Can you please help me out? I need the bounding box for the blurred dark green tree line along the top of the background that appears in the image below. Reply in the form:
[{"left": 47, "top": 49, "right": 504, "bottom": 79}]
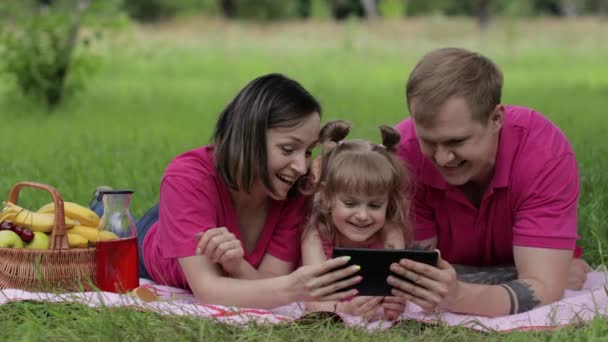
[{"left": 111, "top": 0, "right": 608, "bottom": 22}]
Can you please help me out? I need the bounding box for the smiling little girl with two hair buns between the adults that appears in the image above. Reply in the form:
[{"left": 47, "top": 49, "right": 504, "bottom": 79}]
[{"left": 302, "top": 121, "right": 412, "bottom": 320}]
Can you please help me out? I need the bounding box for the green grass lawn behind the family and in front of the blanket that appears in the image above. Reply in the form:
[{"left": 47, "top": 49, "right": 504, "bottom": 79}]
[{"left": 0, "top": 18, "right": 608, "bottom": 341}]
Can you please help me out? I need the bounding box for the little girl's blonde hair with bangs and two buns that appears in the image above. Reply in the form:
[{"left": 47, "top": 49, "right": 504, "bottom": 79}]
[{"left": 304, "top": 120, "right": 412, "bottom": 246}]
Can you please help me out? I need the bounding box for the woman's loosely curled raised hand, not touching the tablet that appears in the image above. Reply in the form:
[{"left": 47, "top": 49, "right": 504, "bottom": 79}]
[{"left": 195, "top": 227, "right": 245, "bottom": 274}]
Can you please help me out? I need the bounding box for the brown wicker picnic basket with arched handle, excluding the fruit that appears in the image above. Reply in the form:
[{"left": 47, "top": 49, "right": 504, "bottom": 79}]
[{"left": 0, "top": 182, "right": 96, "bottom": 292}]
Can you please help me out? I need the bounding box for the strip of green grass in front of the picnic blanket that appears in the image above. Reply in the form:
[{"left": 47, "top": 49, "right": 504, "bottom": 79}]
[{"left": 0, "top": 302, "right": 608, "bottom": 342}]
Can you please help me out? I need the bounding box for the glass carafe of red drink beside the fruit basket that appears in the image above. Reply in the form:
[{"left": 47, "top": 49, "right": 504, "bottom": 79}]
[{"left": 96, "top": 190, "right": 139, "bottom": 293}]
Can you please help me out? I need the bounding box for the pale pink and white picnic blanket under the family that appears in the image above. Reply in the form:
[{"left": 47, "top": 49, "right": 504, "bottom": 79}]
[{"left": 0, "top": 270, "right": 608, "bottom": 331}]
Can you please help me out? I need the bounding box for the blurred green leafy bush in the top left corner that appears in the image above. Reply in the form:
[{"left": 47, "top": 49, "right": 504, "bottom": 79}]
[{"left": 0, "top": 0, "right": 123, "bottom": 107}]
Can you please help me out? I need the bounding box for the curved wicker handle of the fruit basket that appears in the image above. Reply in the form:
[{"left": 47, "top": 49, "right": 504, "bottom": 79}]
[{"left": 8, "top": 181, "right": 70, "bottom": 250}]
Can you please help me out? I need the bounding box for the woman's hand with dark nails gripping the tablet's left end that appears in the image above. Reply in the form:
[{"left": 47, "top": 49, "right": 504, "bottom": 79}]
[{"left": 287, "top": 257, "right": 363, "bottom": 302}]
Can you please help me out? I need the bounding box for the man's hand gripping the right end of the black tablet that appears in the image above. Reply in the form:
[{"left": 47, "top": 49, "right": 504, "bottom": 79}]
[{"left": 387, "top": 252, "right": 460, "bottom": 311}]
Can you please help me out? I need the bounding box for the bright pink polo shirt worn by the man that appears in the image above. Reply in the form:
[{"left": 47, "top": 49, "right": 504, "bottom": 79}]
[{"left": 396, "top": 106, "right": 580, "bottom": 266}]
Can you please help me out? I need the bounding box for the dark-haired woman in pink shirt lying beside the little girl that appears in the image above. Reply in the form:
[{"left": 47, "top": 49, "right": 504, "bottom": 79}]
[{"left": 92, "top": 74, "right": 359, "bottom": 308}]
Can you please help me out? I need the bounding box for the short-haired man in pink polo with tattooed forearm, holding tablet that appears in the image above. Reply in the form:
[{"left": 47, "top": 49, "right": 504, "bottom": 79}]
[{"left": 388, "top": 48, "right": 589, "bottom": 316}]
